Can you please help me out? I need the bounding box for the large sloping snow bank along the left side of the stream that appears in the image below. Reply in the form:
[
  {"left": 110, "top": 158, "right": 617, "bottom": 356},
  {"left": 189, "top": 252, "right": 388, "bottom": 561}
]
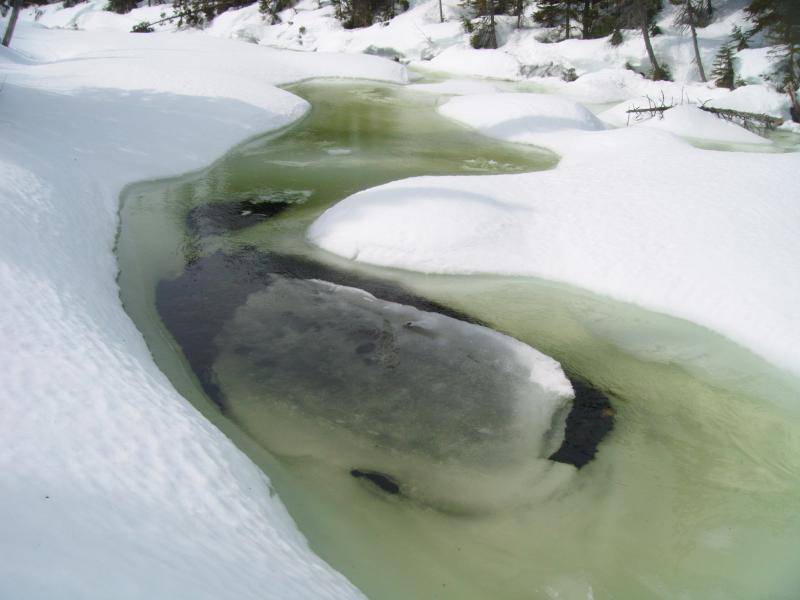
[{"left": 0, "top": 23, "right": 405, "bottom": 600}]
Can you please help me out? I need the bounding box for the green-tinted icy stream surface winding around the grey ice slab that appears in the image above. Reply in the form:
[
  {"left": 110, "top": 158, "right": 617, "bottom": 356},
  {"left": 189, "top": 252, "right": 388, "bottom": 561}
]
[{"left": 118, "top": 83, "right": 800, "bottom": 600}]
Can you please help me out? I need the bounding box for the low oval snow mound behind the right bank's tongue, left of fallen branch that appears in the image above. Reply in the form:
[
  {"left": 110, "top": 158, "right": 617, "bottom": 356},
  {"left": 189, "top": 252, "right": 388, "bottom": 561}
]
[{"left": 439, "top": 93, "right": 604, "bottom": 141}]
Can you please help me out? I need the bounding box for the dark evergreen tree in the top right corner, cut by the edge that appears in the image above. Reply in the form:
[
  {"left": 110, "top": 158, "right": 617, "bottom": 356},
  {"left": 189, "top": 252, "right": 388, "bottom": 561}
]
[{"left": 745, "top": 0, "right": 800, "bottom": 122}]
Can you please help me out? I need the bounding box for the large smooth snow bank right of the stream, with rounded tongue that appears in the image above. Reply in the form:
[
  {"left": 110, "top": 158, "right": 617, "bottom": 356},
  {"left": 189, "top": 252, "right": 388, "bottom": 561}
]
[{"left": 308, "top": 94, "right": 800, "bottom": 380}]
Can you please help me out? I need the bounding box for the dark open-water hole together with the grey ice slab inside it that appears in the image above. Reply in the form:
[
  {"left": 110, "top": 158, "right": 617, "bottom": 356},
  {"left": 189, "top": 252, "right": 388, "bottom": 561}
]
[{"left": 156, "top": 247, "right": 613, "bottom": 511}]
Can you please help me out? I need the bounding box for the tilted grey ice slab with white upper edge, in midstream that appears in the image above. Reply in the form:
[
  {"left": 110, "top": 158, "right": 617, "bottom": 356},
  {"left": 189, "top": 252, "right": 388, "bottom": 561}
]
[{"left": 214, "top": 274, "right": 573, "bottom": 465}]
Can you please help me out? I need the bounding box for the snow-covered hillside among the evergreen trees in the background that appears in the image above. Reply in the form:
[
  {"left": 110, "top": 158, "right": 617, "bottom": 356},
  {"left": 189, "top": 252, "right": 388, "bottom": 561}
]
[{"left": 14, "top": 0, "right": 800, "bottom": 122}]
